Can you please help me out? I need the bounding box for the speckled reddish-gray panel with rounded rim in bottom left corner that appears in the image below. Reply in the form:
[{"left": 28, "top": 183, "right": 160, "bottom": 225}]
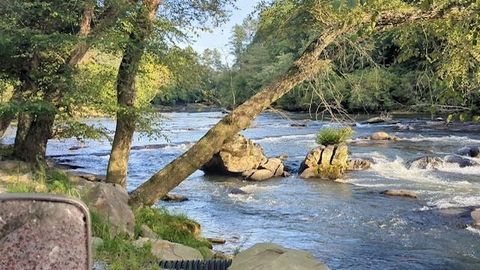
[{"left": 0, "top": 193, "right": 92, "bottom": 270}]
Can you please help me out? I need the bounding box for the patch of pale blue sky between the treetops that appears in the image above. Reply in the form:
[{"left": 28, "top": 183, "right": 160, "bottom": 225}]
[{"left": 188, "top": 0, "right": 260, "bottom": 62}]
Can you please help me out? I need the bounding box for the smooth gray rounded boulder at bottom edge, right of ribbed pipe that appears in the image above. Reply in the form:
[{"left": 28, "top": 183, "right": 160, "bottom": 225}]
[{"left": 228, "top": 243, "right": 329, "bottom": 270}]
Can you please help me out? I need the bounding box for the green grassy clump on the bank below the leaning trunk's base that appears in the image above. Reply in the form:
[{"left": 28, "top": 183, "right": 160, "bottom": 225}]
[{"left": 135, "top": 207, "right": 211, "bottom": 257}]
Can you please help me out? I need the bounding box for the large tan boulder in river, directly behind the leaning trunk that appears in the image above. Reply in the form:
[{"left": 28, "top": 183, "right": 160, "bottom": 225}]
[{"left": 202, "top": 135, "right": 284, "bottom": 181}]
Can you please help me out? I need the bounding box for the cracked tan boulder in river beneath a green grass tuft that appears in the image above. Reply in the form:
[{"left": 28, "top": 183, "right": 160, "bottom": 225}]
[{"left": 299, "top": 144, "right": 349, "bottom": 179}]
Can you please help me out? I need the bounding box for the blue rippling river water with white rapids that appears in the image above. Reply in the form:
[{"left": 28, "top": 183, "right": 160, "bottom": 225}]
[{"left": 31, "top": 112, "right": 480, "bottom": 269}]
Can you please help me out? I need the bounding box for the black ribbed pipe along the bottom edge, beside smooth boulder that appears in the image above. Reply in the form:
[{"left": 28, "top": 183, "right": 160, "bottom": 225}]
[{"left": 159, "top": 260, "right": 232, "bottom": 270}]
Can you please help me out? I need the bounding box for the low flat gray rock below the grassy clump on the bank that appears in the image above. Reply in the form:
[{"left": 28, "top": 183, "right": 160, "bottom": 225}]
[{"left": 133, "top": 238, "right": 203, "bottom": 261}]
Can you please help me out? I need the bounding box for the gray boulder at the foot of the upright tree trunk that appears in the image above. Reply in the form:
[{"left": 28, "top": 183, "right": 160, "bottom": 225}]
[{"left": 84, "top": 183, "right": 135, "bottom": 235}]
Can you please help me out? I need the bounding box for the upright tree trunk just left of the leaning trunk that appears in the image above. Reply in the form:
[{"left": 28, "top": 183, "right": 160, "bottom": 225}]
[{"left": 106, "top": 0, "right": 161, "bottom": 186}]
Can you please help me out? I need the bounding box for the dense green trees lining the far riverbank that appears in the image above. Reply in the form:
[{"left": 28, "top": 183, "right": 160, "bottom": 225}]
[{"left": 154, "top": 0, "right": 480, "bottom": 114}]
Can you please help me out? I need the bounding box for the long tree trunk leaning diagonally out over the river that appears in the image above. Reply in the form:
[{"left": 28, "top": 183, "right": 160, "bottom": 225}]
[{"left": 129, "top": 7, "right": 441, "bottom": 207}]
